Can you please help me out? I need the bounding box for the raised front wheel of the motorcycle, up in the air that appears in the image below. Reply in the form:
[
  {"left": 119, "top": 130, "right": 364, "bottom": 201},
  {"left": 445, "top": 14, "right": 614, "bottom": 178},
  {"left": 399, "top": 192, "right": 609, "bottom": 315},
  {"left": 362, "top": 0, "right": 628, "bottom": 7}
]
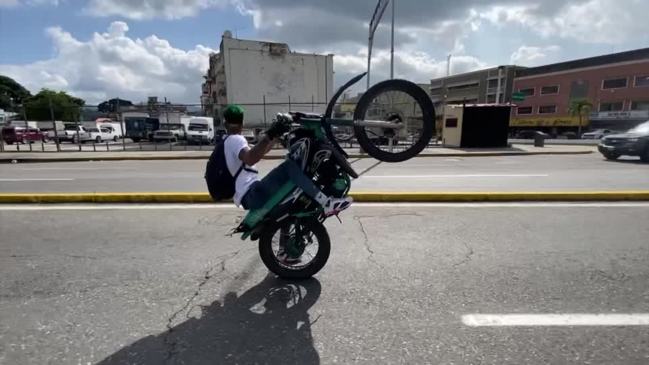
[{"left": 354, "top": 80, "right": 435, "bottom": 162}]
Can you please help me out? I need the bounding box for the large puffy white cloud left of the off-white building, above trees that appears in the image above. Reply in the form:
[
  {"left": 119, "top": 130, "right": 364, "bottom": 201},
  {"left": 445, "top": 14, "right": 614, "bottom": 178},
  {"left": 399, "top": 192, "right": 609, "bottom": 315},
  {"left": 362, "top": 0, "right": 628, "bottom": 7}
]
[{"left": 0, "top": 22, "right": 214, "bottom": 104}]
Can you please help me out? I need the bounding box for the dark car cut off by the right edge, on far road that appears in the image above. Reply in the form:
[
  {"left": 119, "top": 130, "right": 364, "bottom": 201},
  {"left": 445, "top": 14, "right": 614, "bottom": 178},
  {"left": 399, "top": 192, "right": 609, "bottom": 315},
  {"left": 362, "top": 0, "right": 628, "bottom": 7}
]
[{"left": 597, "top": 120, "right": 649, "bottom": 162}]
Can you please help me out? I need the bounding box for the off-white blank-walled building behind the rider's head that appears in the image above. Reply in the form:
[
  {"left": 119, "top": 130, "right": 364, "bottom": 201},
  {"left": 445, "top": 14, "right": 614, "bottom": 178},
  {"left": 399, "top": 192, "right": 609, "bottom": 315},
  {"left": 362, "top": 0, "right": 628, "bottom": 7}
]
[{"left": 201, "top": 31, "right": 333, "bottom": 127}]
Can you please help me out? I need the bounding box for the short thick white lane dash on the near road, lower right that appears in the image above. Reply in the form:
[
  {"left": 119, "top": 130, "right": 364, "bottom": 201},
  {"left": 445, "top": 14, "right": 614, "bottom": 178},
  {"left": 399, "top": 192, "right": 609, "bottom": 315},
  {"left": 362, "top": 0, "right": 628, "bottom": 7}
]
[{"left": 462, "top": 313, "right": 649, "bottom": 327}]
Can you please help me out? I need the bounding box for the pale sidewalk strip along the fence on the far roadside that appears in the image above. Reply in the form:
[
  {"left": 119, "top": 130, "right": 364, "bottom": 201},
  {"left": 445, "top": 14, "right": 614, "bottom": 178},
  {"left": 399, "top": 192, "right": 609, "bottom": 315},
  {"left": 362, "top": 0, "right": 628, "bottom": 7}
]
[{"left": 0, "top": 145, "right": 596, "bottom": 163}]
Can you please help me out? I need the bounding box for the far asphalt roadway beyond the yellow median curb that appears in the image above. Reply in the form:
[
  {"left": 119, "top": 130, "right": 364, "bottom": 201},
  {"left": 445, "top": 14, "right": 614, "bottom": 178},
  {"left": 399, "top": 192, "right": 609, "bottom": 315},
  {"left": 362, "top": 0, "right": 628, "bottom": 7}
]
[{"left": 0, "top": 153, "right": 649, "bottom": 192}]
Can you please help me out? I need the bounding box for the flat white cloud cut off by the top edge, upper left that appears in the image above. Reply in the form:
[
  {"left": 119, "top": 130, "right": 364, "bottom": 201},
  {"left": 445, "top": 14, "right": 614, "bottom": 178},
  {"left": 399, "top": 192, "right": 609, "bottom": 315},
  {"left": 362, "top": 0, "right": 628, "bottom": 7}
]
[{"left": 84, "top": 0, "right": 229, "bottom": 20}]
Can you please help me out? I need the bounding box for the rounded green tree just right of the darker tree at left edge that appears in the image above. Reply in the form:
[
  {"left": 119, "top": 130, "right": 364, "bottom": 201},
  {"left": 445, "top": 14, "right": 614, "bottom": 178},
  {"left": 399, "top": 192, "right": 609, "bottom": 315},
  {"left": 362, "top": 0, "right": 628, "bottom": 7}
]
[{"left": 25, "top": 89, "right": 86, "bottom": 121}]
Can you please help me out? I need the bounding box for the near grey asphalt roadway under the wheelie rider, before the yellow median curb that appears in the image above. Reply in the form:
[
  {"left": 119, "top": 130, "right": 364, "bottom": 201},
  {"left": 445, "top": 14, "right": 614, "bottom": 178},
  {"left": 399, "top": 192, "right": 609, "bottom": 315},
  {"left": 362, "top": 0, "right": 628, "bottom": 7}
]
[{"left": 0, "top": 203, "right": 649, "bottom": 364}]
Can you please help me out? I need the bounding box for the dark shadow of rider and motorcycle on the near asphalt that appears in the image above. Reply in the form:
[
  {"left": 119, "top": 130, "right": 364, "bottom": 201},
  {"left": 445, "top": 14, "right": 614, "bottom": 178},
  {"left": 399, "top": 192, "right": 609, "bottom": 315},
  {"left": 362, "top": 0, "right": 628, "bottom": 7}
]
[{"left": 99, "top": 275, "right": 321, "bottom": 365}]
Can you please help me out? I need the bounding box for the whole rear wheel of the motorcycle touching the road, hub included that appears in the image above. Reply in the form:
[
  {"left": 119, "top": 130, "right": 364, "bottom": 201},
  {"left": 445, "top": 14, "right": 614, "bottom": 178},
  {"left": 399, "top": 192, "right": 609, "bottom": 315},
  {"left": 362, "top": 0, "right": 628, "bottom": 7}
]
[{"left": 259, "top": 218, "right": 331, "bottom": 279}]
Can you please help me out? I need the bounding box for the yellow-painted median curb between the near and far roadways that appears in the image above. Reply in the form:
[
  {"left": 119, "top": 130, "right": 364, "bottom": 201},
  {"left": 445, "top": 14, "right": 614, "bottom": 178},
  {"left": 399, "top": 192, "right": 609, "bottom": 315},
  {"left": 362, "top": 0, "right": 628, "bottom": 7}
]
[{"left": 0, "top": 190, "right": 649, "bottom": 204}]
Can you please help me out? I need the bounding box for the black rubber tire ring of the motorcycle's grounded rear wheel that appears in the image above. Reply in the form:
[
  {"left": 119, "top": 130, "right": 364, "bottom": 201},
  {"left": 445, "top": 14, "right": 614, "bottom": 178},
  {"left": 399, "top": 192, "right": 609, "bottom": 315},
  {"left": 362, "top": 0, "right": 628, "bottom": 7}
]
[{"left": 259, "top": 218, "right": 331, "bottom": 280}]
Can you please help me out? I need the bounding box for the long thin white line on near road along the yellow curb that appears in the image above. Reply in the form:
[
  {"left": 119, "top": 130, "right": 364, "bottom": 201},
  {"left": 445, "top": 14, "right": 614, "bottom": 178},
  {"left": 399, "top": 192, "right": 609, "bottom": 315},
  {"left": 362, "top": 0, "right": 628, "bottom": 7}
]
[{"left": 0, "top": 202, "right": 649, "bottom": 210}]
